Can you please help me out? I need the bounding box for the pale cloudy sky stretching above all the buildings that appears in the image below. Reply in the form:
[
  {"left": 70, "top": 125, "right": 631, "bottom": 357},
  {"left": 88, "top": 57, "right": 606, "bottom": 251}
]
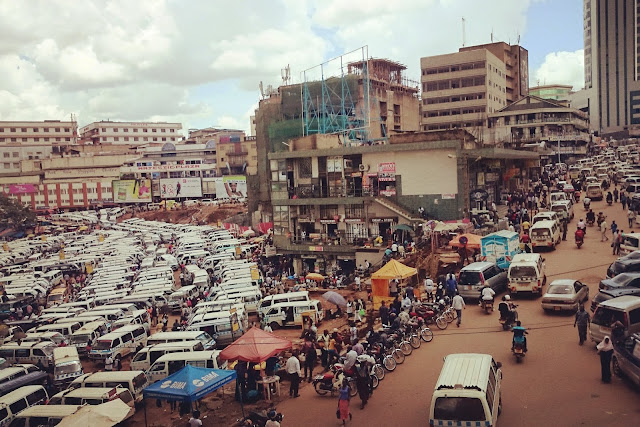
[{"left": 0, "top": 0, "right": 583, "bottom": 133}]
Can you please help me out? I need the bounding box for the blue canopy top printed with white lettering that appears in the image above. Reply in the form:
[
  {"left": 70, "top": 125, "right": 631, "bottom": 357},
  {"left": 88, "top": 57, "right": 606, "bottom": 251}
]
[{"left": 142, "top": 365, "right": 236, "bottom": 402}]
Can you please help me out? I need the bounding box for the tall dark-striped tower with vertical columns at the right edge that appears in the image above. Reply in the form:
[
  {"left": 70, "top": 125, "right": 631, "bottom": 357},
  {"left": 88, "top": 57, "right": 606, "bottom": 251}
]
[{"left": 583, "top": 0, "right": 640, "bottom": 135}]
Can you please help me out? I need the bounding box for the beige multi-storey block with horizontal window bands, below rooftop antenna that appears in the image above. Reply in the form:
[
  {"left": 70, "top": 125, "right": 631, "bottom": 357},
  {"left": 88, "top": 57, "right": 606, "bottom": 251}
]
[{"left": 420, "top": 49, "right": 507, "bottom": 141}]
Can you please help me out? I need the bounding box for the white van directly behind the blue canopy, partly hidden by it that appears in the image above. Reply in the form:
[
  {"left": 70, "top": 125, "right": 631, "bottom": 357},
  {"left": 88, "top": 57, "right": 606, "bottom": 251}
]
[{"left": 147, "top": 350, "right": 227, "bottom": 383}]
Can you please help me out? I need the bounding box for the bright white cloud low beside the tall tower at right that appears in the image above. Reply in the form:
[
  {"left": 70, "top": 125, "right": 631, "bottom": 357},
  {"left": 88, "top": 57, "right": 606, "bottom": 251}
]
[{"left": 530, "top": 49, "right": 584, "bottom": 90}]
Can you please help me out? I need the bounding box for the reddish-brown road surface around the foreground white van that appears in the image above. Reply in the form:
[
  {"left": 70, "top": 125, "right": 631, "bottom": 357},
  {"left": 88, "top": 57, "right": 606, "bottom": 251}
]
[{"left": 278, "top": 202, "right": 640, "bottom": 426}]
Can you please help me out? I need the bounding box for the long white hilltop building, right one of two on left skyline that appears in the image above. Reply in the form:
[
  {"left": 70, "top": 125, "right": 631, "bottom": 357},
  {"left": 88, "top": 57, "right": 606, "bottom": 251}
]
[{"left": 80, "top": 121, "right": 183, "bottom": 146}]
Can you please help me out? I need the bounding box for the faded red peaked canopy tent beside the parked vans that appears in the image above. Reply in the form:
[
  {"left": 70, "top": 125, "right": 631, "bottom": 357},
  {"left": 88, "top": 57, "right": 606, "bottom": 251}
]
[{"left": 220, "top": 326, "right": 292, "bottom": 363}]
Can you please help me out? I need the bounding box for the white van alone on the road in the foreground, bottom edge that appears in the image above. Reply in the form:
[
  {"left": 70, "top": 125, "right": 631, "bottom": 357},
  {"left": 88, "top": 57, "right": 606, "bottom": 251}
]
[{"left": 429, "top": 353, "right": 502, "bottom": 426}]
